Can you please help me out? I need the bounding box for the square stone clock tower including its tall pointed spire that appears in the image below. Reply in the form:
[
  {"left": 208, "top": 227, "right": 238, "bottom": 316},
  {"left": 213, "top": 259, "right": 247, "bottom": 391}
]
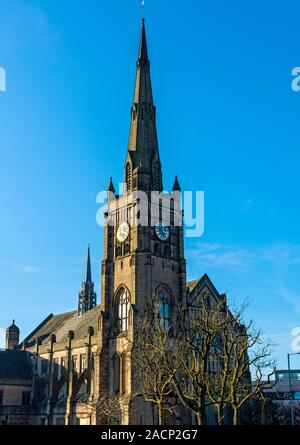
[{"left": 99, "top": 19, "right": 186, "bottom": 424}]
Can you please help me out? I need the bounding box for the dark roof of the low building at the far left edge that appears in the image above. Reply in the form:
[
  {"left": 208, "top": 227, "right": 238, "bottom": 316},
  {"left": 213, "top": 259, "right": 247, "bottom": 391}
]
[{"left": 0, "top": 349, "right": 32, "bottom": 380}]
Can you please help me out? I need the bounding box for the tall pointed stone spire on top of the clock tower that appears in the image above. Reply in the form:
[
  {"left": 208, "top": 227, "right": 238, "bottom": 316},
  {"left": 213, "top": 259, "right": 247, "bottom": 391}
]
[{"left": 124, "top": 18, "right": 163, "bottom": 191}]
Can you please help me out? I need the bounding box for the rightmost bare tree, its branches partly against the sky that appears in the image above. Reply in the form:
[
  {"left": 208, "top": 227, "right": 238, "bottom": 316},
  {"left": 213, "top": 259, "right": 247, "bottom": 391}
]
[{"left": 207, "top": 305, "right": 275, "bottom": 425}]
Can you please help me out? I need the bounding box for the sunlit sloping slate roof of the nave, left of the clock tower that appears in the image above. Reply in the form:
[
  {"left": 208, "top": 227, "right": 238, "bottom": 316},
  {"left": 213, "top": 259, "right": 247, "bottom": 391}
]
[{"left": 23, "top": 305, "right": 100, "bottom": 348}]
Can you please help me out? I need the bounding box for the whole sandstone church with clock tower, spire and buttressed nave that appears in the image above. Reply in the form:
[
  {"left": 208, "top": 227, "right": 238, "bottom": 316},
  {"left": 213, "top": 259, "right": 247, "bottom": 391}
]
[{"left": 0, "top": 20, "right": 226, "bottom": 425}]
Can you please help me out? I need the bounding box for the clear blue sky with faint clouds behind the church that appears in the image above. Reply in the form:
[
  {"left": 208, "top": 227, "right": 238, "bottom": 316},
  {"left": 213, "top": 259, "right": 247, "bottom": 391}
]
[{"left": 0, "top": 0, "right": 300, "bottom": 367}]
